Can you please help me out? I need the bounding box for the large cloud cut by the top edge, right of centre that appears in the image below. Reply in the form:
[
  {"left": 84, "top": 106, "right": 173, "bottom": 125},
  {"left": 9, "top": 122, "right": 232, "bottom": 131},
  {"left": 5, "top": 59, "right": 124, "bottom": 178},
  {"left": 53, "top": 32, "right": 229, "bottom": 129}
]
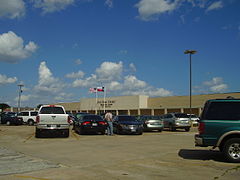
[{"left": 135, "top": 0, "right": 180, "bottom": 21}]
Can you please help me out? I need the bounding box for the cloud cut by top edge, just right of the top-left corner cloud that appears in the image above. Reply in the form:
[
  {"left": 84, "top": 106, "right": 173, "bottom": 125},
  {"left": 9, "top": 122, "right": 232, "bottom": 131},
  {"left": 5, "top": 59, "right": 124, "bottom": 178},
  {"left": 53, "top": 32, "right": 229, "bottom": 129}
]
[{"left": 32, "top": 0, "right": 75, "bottom": 14}]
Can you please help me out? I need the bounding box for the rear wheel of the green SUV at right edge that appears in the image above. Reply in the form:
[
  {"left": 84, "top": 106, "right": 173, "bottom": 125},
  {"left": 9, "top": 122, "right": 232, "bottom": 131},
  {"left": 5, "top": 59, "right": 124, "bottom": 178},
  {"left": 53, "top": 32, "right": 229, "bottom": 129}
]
[{"left": 223, "top": 138, "right": 240, "bottom": 163}]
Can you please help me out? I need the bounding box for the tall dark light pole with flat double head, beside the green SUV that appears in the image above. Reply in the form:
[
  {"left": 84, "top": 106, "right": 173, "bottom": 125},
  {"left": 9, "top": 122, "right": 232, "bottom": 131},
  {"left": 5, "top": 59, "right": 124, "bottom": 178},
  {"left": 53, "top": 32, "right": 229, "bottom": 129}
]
[{"left": 184, "top": 50, "right": 197, "bottom": 121}]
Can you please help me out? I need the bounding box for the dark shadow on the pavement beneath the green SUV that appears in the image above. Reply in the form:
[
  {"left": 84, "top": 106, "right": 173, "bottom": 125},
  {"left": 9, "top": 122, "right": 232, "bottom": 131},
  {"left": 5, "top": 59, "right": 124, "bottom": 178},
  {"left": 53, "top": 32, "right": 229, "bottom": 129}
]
[{"left": 178, "top": 149, "right": 226, "bottom": 162}]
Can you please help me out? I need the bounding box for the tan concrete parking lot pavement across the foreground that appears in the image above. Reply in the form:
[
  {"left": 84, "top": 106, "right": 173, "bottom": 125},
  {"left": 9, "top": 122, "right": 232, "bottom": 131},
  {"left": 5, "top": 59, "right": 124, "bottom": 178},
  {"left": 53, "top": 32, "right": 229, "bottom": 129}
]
[{"left": 0, "top": 126, "right": 240, "bottom": 180}]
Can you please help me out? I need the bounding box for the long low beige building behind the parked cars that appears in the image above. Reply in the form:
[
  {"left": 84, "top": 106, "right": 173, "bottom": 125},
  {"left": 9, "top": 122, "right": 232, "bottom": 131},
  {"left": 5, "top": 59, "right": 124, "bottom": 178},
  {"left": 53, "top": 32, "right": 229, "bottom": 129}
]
[{"left": 57, "top": 92, "right": 240, "bottom": 115}]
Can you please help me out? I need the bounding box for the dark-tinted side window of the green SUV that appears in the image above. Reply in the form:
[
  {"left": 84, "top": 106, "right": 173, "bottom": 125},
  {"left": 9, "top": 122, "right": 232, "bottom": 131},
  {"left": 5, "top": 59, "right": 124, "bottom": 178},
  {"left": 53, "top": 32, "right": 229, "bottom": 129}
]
[{"left": 202, "top": 102, "right": 240, "bottom": 120}]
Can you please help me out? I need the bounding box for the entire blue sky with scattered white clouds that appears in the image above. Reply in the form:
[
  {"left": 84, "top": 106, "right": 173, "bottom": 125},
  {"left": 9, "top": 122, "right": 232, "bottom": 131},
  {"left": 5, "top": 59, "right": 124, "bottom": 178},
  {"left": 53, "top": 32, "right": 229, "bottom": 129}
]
[{"left": 0, "top": 0, "right": 240, "bottom": 107}]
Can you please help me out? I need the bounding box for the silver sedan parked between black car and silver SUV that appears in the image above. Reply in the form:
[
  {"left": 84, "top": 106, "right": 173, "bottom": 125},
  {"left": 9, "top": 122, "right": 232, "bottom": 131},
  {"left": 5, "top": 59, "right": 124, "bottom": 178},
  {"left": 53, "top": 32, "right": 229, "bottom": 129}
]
[{"left": 139, "top": 115, "right": 163, "bottom": 132}]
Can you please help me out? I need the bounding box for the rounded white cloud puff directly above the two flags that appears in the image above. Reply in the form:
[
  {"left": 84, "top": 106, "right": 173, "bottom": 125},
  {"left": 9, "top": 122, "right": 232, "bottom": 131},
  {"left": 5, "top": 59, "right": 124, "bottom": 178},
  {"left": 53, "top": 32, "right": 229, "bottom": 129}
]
[{"left": 96, "top": 61, "right": 123, "bottom": 81}]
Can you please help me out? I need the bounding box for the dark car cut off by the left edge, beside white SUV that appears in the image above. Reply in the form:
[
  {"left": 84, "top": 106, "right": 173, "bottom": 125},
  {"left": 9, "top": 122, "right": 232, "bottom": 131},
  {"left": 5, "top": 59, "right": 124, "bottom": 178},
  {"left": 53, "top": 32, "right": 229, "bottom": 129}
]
[{"left": 0, "top": 112, "right": 23, "bottom": 125}]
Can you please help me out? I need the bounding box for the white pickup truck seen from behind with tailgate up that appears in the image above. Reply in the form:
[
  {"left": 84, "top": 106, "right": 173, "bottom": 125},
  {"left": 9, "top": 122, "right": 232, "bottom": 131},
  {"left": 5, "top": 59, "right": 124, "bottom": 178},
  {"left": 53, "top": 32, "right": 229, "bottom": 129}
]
[{"left": 35, "top": 105, "right": 71, "bottom": 138}]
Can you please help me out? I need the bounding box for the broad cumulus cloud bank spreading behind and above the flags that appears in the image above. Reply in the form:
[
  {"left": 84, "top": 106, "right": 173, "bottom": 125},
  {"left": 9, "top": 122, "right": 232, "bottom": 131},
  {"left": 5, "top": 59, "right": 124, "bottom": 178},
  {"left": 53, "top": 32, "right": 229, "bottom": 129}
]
[{"left": 72, "top": 61, "right": 172, "bottom": 96}]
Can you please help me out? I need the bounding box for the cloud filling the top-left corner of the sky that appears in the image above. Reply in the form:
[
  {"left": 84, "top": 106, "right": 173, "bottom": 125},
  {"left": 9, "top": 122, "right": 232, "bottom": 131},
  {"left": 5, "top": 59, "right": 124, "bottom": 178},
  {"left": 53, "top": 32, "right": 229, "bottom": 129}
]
[{"left": 0, "top": 0, "right": 25, "bottom": 19}]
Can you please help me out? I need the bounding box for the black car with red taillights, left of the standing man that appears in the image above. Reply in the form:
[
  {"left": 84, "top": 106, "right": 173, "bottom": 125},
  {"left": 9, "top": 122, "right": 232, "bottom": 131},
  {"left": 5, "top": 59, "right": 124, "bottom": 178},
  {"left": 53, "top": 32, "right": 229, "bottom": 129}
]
[{"left": 73, "top": 114, "right": 108, "bottom": 134}]
